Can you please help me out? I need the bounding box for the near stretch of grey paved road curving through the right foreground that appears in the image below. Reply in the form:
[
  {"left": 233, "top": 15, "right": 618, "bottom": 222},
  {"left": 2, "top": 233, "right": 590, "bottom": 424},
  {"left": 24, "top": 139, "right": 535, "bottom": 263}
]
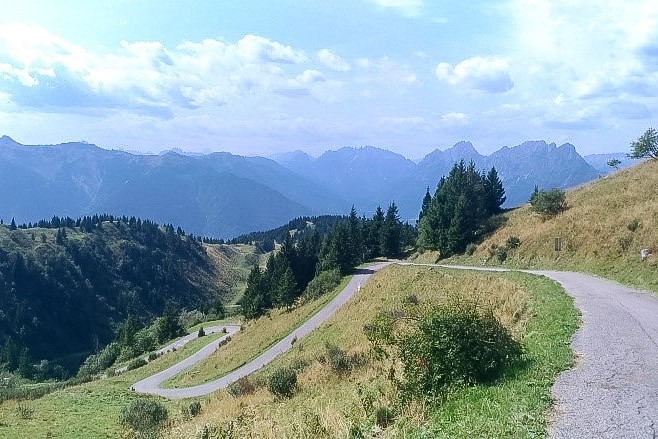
[{"left": 404, "top": 264, "right": 658, "bottom": 439}]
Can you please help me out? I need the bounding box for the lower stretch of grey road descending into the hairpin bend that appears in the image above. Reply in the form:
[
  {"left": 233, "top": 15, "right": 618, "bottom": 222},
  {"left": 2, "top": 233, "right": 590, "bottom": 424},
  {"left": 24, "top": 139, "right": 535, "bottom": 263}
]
[{"left": 132, "top": 262, "right": 390, "bottom": 399}]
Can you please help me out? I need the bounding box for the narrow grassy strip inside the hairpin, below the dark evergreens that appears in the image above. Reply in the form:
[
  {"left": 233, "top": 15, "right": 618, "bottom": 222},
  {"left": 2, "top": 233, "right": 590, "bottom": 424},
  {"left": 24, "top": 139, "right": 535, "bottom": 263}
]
[{"left": 163, "top": 277, "right": 350, "bottom": 388}]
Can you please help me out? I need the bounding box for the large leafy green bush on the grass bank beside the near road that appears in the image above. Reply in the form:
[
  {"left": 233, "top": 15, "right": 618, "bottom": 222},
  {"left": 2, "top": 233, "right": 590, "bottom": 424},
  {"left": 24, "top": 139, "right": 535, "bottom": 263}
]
[{"left": 364, "top": 305, "right": 521, "bottom": 398}]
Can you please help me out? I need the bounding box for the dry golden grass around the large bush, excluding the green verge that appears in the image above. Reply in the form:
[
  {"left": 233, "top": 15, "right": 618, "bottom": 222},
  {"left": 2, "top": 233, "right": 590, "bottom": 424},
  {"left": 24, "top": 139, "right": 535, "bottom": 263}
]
[{"left": 170, "top": 266, "right": 529, "bottom": 438}]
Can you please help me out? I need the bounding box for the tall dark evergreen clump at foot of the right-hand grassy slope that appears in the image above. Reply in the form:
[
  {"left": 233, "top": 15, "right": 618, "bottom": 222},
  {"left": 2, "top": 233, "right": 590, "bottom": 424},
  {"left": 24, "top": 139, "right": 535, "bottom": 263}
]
[{"left": 418, "top": 160, "right": 505, "bottom": 258}]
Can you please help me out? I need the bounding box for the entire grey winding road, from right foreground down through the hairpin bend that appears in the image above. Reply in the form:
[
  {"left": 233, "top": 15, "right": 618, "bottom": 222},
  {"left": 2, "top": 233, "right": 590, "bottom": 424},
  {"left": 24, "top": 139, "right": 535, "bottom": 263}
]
[{"left": 129, "top": 262, "right": 658, "bottom": 439}]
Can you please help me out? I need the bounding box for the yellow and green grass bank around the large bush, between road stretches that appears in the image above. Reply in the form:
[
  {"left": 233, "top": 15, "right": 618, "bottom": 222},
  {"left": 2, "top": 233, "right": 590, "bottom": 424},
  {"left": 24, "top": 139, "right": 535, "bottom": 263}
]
[{"left": 168, "top": 266, "right": 578, "bottom": 438}]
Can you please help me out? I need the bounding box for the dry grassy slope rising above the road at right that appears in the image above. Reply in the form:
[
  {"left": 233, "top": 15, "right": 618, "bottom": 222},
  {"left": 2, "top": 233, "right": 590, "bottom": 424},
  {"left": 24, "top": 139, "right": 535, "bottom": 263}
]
[{"left": 440, "top": 161, "right": 658, "bottom": 293}]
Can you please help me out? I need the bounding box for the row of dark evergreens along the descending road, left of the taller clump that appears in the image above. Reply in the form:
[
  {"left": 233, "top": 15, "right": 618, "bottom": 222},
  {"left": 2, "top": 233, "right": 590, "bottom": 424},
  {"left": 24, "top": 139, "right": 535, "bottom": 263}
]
[{"left": 242, "top": 203, "right": 415, "bottom": 319}]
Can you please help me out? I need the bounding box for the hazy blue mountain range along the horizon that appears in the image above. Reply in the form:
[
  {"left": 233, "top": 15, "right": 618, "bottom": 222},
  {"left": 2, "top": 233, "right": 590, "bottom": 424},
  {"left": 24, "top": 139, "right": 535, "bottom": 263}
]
[{"left": 0, "top": 136, "right": 624, "bottom": 237}]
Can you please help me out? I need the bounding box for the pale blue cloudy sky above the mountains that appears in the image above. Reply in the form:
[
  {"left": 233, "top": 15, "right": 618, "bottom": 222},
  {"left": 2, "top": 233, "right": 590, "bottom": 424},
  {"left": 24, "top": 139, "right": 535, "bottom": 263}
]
[{"left": 0, "top": 0, "right": 658, "bottom": 159}]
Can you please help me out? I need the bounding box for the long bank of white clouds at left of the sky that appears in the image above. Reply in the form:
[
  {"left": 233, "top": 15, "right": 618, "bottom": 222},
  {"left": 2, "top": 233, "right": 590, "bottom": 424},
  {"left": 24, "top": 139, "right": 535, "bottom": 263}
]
[{"left": 0, "top": 23, "right": 312, "bottom": 112}]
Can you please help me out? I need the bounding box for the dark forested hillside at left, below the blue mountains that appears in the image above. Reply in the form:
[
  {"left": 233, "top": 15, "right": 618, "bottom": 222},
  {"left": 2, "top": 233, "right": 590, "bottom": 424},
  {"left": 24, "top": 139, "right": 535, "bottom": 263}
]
[{"left": 0, "top": 216, "right": 230, "bottom": 371}]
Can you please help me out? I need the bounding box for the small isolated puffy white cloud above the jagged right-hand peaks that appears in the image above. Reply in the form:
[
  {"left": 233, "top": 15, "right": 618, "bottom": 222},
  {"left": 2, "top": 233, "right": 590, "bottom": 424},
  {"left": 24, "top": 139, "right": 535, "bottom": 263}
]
[{"left": 435, "top": 56, "right": 514, "bottom": 93}]
